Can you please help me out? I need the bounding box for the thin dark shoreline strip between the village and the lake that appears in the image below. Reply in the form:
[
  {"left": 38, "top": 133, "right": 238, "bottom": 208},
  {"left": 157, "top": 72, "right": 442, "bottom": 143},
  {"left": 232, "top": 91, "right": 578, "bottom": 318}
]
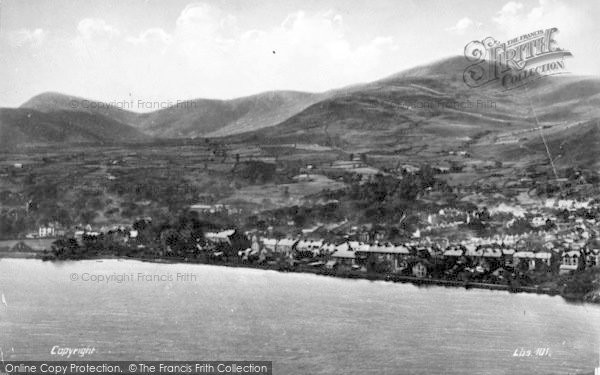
[{"left": 0, "top": 252, "right": 595, "bottom": 304}]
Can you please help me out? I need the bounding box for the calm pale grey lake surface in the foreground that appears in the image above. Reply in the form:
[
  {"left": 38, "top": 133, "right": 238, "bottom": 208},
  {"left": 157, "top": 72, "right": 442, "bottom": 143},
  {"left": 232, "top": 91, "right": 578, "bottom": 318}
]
[{"left": 0, "top": 259, "right": 600, "bottom": 375}]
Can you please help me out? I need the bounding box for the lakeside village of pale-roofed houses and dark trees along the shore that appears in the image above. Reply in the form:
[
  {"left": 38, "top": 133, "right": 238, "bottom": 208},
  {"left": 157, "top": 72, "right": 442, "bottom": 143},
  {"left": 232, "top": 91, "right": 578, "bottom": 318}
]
[{"left": 0, "top": 188, "right": 600, "bottom": 302}]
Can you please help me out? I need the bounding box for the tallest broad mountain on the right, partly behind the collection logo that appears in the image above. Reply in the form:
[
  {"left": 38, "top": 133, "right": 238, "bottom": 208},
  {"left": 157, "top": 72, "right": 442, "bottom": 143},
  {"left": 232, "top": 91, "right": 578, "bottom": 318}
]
[{"left": 232, "top": 57, "right": 600, "bottom": 164}]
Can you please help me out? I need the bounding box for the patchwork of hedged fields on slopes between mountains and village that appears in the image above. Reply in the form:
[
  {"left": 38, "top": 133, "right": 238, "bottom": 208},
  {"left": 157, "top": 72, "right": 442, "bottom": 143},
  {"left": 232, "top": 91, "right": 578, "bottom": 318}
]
[{"left": 0, "top": 124, "right": 597, "bottom": 238}]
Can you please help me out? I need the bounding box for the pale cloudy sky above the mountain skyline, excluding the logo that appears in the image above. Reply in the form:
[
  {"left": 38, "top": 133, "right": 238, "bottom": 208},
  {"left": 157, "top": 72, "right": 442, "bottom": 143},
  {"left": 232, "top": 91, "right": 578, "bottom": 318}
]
[{"left": 0, "top": 0, "right": 600, "bottom": 111}]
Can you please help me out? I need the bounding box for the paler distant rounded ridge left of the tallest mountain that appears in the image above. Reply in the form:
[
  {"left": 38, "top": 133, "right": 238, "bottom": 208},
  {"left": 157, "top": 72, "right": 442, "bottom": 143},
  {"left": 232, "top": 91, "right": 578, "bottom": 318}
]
[{"left": 20, "top": 91, "right": 324, "bottom": 138}]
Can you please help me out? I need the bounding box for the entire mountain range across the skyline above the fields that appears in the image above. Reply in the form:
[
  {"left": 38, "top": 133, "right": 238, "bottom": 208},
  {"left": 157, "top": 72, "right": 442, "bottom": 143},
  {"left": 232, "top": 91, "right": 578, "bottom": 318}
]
[{"left": 8, "top": 56, "right": 600, "bottom": 160}]
